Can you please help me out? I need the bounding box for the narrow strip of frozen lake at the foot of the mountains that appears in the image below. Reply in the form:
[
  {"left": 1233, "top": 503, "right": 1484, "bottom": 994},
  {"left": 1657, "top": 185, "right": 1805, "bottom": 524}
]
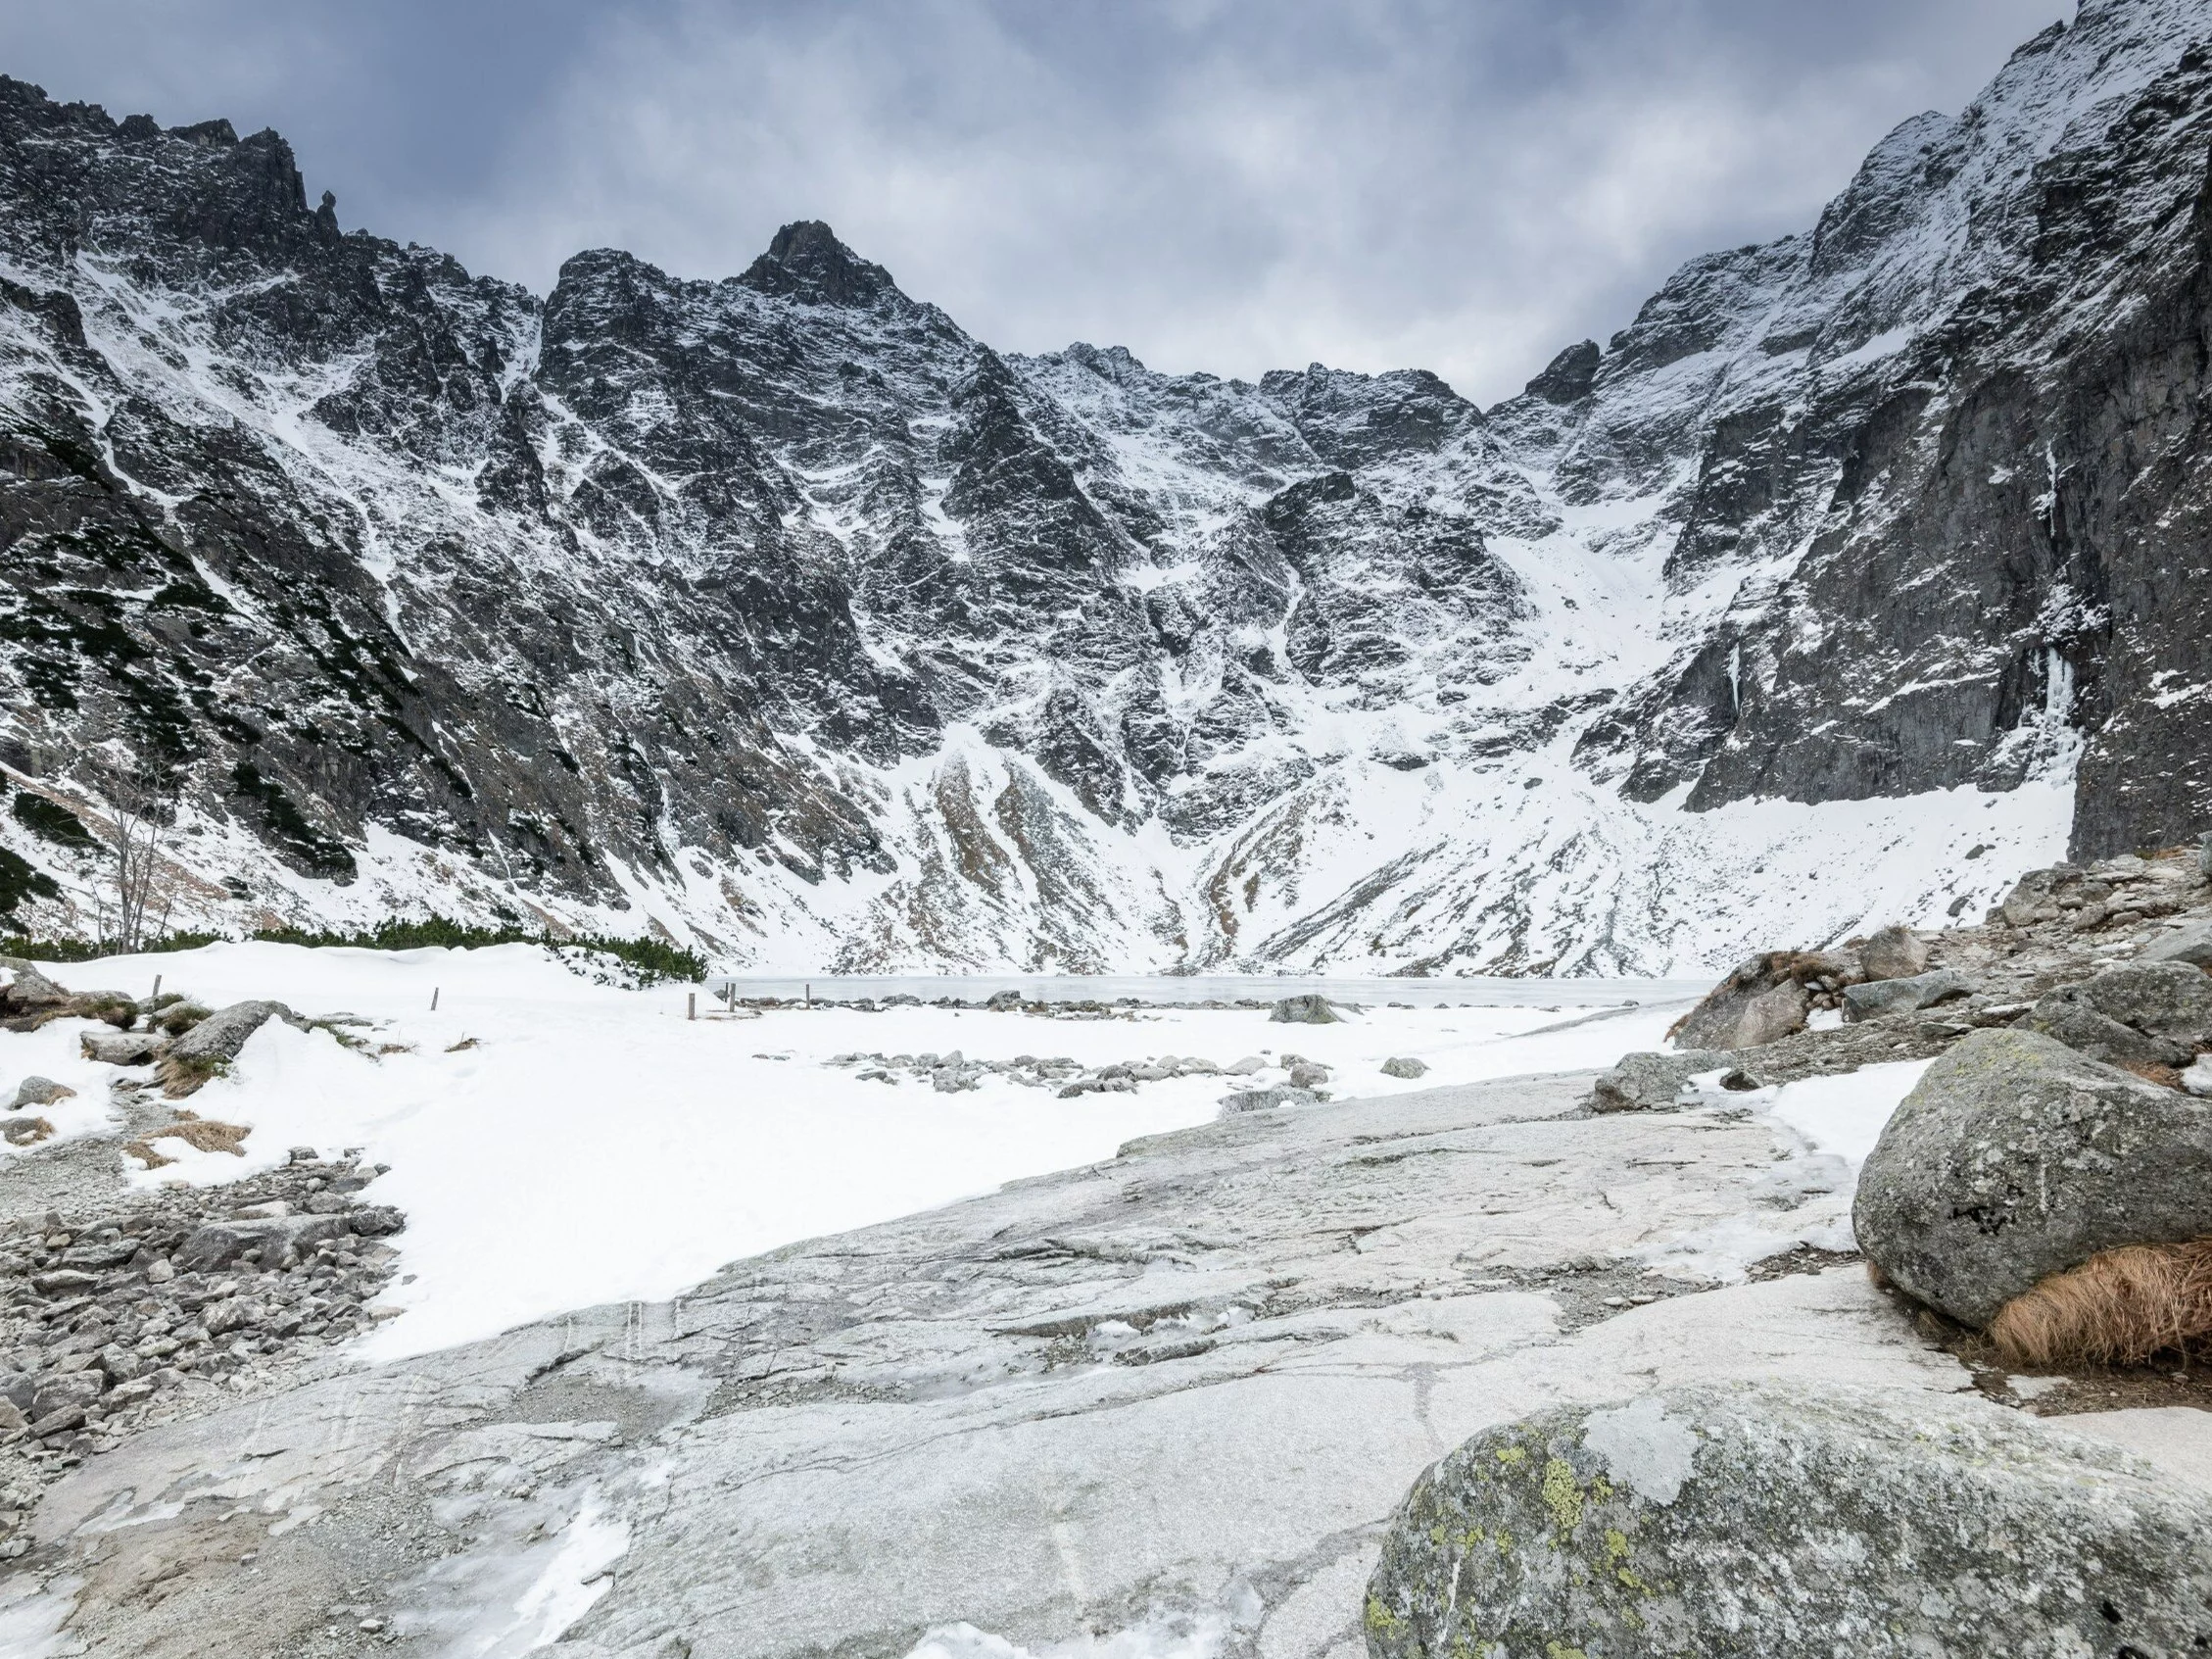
[{"left": 708, "top": 973, "right": 1712, "bottom": 1008}]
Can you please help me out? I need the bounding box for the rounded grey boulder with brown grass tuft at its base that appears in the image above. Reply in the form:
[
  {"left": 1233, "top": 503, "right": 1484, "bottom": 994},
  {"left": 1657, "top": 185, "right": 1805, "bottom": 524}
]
[{"left": 1851, "top": 1029, "right": 2212, "bottom": 1327}]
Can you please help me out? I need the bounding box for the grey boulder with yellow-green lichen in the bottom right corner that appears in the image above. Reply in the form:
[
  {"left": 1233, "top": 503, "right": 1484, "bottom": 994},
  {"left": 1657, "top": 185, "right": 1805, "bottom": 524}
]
[{"left": 1365, "top": 1383, "right": 2212, "bottom": 1659}]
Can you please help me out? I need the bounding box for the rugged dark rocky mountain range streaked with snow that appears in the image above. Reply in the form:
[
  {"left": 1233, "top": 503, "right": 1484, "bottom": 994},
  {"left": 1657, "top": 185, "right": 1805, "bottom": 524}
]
[{"left": 0, "top": 0, "right": 2212, "bottom": 973}]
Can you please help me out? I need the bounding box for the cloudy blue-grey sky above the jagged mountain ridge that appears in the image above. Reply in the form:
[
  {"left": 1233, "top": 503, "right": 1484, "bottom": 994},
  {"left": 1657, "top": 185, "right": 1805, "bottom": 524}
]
[{"left": 0, "top": 0, "right": 2073, "bottom": 403}]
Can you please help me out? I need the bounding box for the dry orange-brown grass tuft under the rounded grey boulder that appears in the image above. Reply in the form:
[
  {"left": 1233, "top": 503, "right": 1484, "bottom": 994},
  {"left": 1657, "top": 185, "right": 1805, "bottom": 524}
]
[{"left": 1989, "top": 1239, "right": 2212, "bottom": 1369}]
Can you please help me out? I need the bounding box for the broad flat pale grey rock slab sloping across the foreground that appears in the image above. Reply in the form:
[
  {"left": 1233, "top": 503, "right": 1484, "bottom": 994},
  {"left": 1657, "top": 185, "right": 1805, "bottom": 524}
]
[{"left": 14, "top": 1073, "right": 1966, "bottom": 1659}]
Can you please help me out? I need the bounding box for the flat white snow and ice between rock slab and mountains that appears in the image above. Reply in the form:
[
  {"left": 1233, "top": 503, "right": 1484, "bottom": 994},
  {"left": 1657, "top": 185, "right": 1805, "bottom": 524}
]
[{"left": 0, "top": 945, "right": 1875, "bottom": 1358}]
